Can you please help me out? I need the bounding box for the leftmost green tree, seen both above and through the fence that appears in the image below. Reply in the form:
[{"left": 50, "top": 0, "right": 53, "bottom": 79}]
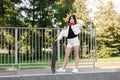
[{"left": 0, "top": 0, "right": 21, "bottom": 54}]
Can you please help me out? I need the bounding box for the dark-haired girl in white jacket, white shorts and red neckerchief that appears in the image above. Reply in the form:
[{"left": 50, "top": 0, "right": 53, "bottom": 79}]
[{"left": 55, "top": 15, "right": 84, "bottom": 73}]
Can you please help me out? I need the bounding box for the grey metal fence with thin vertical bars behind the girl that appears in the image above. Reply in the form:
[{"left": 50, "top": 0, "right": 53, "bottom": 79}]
[{"left": 0, "top": 27, "right": 96, "bottom": 68}]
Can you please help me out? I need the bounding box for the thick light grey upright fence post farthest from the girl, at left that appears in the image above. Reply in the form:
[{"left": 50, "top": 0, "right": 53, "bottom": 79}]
[{"left": 15, "top": 28, "right": 18, "bottom": 64}]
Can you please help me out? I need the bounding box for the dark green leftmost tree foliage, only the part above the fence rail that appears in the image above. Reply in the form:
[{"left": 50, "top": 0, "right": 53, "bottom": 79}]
[{"left": 0, "top": 0, "right": 21, "bottom": 26}]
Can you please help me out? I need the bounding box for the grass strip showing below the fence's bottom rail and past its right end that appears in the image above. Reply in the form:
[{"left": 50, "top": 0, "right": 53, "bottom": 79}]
[{"left": 0, "top": 57, "right": 120, "bottom": 70}]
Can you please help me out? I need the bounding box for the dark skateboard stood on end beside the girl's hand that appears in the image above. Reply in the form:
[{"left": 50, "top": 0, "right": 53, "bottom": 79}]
[{"left": 51, "top": 41, "right": 57, "bottom": 73}]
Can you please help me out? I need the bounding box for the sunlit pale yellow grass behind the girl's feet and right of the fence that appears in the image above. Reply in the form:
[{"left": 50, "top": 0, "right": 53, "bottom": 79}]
[{"left": 62, "top": 57, "right": 120, "bottom": 68}]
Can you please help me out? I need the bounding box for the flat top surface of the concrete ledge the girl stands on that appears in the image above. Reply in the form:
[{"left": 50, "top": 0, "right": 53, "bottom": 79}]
[{"left": 0, "top": 66, "right": 120, "bottom": 77}]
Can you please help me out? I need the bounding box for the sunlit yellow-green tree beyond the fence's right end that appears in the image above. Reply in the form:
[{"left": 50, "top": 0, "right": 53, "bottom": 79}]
[{"left": 95, "top": 0, "right": 120, "bottom": 57}]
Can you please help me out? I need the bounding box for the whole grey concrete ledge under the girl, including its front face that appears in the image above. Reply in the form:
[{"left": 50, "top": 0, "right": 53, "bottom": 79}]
[{"left": 0, "top": 66, "right": 120, "bottom": 80}]
